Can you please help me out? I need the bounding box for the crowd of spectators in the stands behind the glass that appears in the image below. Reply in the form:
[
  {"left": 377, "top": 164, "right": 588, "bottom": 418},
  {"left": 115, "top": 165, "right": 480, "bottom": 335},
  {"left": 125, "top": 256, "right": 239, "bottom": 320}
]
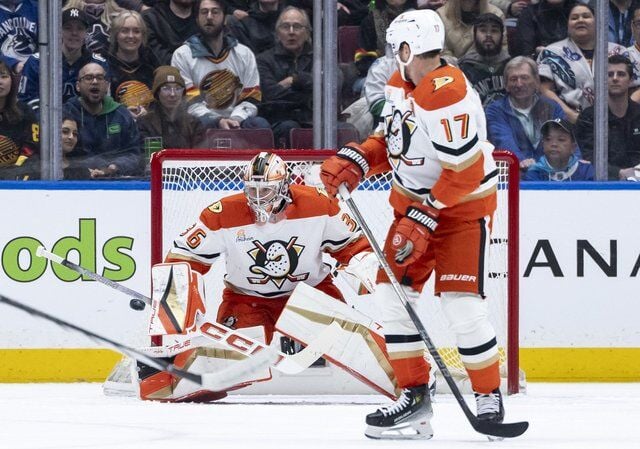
[{"left": 0, "top": 0, "right": 640, "bottom": 181}]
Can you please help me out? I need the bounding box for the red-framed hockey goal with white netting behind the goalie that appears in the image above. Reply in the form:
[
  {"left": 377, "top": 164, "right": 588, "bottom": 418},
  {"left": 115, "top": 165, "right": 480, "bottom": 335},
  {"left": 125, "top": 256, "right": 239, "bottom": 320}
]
[{"left": 151, "top": 149, "right": 525, "bottom": 394}]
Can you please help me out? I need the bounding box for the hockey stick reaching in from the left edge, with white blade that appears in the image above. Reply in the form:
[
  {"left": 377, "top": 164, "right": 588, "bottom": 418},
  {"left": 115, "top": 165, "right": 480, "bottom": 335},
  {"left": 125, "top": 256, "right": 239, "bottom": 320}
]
[{"left": 0, "top": 295, "right": 277, "bottom": 391}]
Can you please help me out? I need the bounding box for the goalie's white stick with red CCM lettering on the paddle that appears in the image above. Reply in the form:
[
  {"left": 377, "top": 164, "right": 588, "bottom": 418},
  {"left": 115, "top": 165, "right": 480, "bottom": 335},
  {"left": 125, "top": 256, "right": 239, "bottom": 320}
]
[{"left": 36, "top": 246, "right": 341, "bottom": 374}]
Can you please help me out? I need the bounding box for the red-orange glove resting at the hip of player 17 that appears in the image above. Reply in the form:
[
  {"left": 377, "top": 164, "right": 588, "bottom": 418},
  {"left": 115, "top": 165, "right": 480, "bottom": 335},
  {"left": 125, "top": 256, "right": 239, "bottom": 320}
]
[{"left": 391, "top": 202, "right": 440, "bottom": 267}]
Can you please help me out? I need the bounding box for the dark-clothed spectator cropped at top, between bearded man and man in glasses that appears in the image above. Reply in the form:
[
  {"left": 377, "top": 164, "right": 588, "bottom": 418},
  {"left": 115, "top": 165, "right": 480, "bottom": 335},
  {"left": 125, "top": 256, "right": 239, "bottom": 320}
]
[{"left": 227, "top": 0, "right": 282, "bottom": 55}]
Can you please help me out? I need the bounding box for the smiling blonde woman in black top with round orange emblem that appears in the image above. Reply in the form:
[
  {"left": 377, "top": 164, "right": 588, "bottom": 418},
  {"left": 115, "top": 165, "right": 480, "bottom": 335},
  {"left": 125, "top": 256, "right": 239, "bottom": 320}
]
[{"left": 107, "top": 10, "right": 158, "bottom": 118}]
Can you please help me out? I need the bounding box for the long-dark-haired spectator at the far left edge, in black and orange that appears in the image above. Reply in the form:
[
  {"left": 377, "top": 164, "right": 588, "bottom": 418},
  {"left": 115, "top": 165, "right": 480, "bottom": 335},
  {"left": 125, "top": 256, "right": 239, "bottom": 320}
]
[{"left": 0, "top": 56, "right": 39, "bottom": 179}]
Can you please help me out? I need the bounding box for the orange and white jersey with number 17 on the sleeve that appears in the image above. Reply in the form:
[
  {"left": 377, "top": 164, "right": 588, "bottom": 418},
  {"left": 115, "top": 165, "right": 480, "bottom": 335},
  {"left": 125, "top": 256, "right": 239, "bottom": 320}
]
[{"left": 362, "top": 63, "right": 498, "bottom": 219}]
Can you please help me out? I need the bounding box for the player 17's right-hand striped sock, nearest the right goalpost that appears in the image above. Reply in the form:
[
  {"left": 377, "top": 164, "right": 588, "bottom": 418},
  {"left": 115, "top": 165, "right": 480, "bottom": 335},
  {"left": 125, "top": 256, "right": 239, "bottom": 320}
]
[{"left": 440, "top": 292, "right": 500, "bottom": 394}]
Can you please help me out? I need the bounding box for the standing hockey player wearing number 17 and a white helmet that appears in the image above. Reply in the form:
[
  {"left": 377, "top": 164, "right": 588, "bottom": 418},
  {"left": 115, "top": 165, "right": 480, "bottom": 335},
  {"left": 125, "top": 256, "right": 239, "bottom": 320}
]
[{"left": 321, "top": 10, "right": 504, "bottom": 438}]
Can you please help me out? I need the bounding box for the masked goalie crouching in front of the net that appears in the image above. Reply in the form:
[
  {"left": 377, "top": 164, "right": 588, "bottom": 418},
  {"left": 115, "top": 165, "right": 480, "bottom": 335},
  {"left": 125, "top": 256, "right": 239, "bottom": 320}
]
[{"left": 140, "top": 152, "right": 384, "bottom": 400}]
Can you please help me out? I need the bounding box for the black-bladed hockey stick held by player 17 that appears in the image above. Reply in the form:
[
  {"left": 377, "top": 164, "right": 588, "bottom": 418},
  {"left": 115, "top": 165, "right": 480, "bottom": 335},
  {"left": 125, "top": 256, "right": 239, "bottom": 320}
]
[{"left": 338, "top": 184, "right": 529, "bottom": 438}]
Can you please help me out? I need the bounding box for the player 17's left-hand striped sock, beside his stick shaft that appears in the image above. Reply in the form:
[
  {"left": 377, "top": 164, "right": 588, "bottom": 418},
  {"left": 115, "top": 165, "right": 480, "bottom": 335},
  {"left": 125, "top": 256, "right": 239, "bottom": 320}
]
[{"left": 374, "top": 283, "right": 430, "bottom": 388}]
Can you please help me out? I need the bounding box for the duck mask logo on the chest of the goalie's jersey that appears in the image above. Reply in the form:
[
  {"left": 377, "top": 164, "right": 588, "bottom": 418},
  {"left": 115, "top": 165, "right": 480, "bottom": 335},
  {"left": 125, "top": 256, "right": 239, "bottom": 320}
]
[{"left": 247, "top": 237, "right": 309, "bottom": 288}]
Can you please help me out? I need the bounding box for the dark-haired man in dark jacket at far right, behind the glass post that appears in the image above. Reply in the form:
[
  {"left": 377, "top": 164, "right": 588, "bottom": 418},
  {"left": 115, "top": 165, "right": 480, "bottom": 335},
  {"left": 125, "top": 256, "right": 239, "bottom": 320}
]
[{"left": 576, "top": 55, "right": 640, "bottom": 180}]
